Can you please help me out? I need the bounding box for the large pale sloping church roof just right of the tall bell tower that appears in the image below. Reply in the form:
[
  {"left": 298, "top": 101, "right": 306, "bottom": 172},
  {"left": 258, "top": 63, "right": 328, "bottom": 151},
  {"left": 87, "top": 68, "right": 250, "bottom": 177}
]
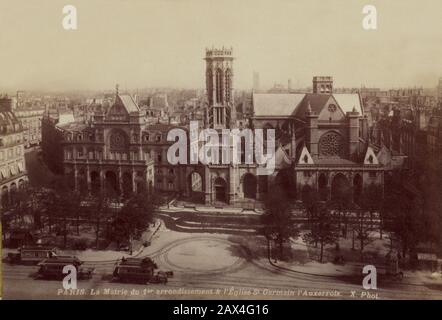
[{"left": 252, "top": 93, "right": 304, "bottom": 117}]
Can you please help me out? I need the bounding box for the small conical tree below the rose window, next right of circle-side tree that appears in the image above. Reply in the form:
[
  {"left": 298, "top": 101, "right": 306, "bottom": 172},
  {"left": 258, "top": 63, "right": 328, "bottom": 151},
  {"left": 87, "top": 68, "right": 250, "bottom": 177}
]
[{"left": 303, "top": 204, "right": 339, "bottom": 263}]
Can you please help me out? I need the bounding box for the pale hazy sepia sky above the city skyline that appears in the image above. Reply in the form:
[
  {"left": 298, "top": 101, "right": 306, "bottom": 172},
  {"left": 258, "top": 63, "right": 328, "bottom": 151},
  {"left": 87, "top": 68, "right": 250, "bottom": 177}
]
[{"left": 0, "top": 0, "right": 442, "bottom": 90}]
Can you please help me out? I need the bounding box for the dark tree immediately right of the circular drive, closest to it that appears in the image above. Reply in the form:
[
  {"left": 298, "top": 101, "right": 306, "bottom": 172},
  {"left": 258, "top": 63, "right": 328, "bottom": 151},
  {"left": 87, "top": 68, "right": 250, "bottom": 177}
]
[{"left": 261, "top": 188, "right": 299, "bottom": 258}]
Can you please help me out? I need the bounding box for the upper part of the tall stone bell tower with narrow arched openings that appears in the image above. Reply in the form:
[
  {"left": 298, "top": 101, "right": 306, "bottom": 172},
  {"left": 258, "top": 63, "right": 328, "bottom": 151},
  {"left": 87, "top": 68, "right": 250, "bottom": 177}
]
[{"left": 204, "top": 47, "right": 235, "bottom": 129}]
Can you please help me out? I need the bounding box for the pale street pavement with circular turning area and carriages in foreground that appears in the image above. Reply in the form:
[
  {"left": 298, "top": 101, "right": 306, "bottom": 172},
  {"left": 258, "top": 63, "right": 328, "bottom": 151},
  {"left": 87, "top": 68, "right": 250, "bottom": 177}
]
[{"left": 3, "top": 227, "right": 442, "bottom": 299}]
